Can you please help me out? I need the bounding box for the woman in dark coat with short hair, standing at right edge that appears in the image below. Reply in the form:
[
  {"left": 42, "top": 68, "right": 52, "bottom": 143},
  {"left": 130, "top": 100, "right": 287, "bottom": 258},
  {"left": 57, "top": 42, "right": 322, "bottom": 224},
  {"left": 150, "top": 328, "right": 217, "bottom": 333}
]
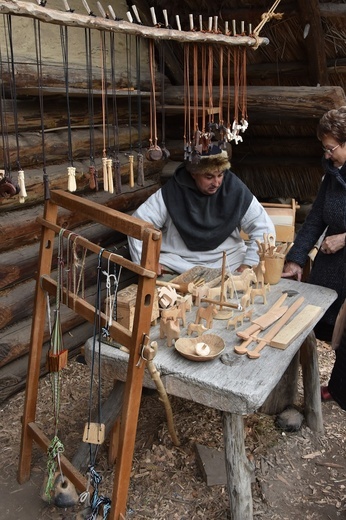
[{"left": 282, "top": 106, "right": 346, "bottom": 399}]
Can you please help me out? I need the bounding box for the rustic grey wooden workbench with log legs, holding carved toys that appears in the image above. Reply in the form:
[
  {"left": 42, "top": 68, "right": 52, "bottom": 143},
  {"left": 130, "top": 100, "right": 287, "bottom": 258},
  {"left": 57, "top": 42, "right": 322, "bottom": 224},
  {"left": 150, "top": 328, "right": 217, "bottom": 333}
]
[{"left": 85, "top": 279, "right": 337, "bottom": 520}]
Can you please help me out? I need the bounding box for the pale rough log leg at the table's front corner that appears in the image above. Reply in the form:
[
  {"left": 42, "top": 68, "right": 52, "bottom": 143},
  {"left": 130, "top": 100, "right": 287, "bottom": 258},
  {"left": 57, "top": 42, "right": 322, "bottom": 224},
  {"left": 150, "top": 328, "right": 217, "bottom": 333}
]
[{"left": 223, "top": 412, "right": 253, "bottom": 520}]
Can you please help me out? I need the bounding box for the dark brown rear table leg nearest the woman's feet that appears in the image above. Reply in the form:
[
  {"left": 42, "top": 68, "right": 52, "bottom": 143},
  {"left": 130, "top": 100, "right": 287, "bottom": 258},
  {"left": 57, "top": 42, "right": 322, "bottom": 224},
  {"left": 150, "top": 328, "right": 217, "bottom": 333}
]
[{"left": 300, "top": 332, "right": 324, "bottom": 434}]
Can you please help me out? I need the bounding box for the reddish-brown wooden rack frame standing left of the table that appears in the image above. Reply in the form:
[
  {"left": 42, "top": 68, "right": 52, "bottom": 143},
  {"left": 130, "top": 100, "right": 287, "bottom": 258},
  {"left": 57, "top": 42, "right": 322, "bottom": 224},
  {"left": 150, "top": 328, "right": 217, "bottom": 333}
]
[{"left": 18, "top": 190, "right": 161, "bottom": 520}]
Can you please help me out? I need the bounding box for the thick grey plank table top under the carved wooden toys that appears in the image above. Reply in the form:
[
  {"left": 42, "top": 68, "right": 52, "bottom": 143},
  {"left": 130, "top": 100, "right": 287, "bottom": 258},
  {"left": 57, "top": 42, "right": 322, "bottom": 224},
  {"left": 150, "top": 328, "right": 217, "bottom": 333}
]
[{"left": 85, "top": 279, "right": 337, "bottom": 415}]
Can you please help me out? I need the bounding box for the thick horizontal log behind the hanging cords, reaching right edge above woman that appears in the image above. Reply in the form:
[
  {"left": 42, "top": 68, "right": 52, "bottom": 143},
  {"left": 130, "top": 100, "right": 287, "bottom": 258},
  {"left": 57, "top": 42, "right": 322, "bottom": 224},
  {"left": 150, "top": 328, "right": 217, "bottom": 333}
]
[{"left": 162, "top": 86, "right": 346, "bottom": 119}]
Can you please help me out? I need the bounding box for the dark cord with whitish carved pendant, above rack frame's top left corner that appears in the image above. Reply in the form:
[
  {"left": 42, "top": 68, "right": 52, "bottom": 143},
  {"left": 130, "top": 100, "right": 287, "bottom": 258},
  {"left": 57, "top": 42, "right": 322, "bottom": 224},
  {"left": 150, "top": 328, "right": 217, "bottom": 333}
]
[{"left": 60, "top": 26, "right": 77, "bottom": 192}]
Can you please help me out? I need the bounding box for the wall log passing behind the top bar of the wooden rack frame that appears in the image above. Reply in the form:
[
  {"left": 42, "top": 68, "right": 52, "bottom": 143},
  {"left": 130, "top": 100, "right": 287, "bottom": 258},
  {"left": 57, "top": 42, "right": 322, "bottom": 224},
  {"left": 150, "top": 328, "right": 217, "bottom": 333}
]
[{"left": 0, "top": 181, "right": 159, "bottom": 253}]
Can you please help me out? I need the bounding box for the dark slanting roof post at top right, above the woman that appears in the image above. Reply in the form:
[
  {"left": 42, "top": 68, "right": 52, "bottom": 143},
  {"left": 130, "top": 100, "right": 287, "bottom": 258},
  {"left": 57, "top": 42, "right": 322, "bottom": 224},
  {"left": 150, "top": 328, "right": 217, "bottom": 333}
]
[{"left": 297, "top": 0, "right": 329, "bottom": 86}]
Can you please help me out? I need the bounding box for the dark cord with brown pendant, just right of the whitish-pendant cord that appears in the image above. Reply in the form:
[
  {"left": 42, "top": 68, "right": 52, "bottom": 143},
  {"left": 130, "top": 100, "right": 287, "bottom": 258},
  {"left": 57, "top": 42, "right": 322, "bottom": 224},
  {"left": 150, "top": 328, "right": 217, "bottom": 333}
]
[{"left": 84, "top": 28, "right": 99, "bottom": 191}]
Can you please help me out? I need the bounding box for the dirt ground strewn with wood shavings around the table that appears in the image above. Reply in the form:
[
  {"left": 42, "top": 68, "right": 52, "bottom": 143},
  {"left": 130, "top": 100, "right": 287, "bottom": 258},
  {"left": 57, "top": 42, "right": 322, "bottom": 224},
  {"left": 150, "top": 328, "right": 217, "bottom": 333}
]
[{"left": 0, "top": 343, "right": 346, "bottom": 520}]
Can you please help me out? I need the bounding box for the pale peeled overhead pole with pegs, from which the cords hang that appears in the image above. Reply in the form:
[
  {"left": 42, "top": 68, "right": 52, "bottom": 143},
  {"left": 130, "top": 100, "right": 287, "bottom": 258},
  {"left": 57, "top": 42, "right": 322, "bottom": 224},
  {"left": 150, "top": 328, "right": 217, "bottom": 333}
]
[{"left": 0, "top": 0, "right": 269, "bottom": 48}]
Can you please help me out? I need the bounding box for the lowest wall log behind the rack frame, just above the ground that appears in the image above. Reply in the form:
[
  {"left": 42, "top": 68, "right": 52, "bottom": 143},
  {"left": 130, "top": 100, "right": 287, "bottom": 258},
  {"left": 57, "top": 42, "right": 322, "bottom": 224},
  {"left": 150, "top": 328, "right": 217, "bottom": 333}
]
[{"left": 0, "top": 323, "right": 93, "bottom": 403}]
